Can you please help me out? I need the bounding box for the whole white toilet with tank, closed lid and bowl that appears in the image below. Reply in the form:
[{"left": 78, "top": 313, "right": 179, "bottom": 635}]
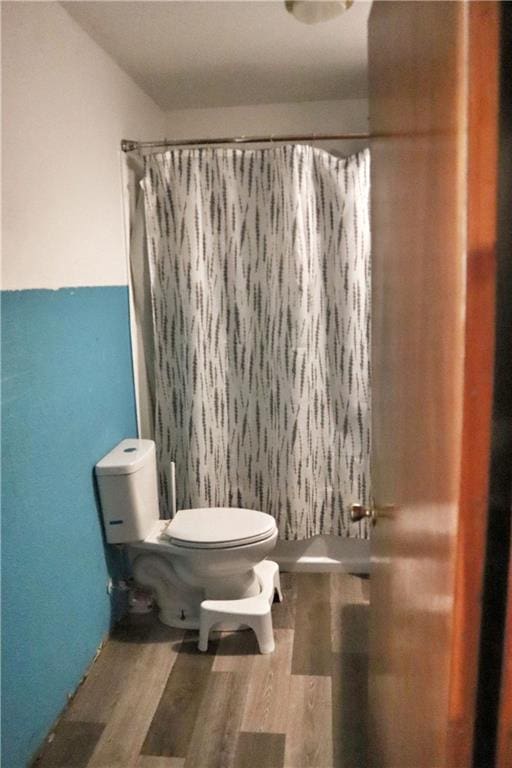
[{"left": 95, "top": 439, "right": 277, "bottom": 629}]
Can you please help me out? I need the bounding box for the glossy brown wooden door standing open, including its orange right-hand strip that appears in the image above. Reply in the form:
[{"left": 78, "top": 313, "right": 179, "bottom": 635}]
[{"left": 369, "top": 2, "right": 498, "bottom": 768}]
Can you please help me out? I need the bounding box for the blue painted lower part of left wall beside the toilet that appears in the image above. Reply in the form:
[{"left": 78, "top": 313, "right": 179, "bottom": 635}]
[{"left": 2, "top": 286, "right": 136, "bottom": 768}]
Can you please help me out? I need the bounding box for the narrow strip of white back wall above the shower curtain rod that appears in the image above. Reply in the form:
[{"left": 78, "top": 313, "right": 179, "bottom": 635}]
[{"left": 165, "top": 99, "right": 368, "bottom": 154}]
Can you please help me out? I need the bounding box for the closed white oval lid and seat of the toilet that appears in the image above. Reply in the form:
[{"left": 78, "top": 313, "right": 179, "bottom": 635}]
[{"left": 165, "top": 507, "right": 276, "bottom": 549}]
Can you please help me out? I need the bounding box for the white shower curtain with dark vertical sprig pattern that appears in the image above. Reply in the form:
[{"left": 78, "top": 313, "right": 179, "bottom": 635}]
[{"left": 142, "top": 146, "right": 370, "bottom": 539}]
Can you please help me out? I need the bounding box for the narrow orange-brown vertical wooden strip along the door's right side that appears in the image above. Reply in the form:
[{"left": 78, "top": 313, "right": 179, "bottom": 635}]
[{"left": 448, "top": 0, "right": 500, "bottom": 768}]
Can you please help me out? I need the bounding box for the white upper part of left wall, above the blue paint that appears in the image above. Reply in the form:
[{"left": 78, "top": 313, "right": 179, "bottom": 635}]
[{"left": 2, "top": 2, "right": 165, "bottom": 289}]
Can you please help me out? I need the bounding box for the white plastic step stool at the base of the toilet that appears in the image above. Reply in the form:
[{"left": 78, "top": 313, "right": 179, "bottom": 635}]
[{"left": 199, "top": 560, "right": 283, "bottom": 653}]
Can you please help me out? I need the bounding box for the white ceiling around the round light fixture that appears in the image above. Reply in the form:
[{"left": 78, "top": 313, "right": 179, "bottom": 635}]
[{"left": 62, "top": 0, "right": 371, "bottom": 109}]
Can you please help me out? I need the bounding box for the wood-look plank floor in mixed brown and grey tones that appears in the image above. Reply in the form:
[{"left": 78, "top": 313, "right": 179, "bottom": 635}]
[{"left": 35, "top": 573, "right": 369, "bottom": 768}]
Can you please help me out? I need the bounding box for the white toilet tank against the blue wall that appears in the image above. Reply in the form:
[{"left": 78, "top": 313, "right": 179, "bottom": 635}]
[{"left": 96, "top": 438, "right": 159, "bottom": 544}]
